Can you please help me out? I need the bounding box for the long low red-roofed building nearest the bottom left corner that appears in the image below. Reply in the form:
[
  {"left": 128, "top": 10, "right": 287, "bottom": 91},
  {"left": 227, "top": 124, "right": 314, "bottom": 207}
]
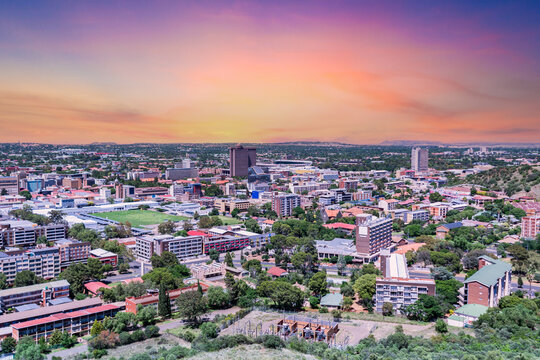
[{"left": 11, "top": 304, "right": 121, "bottom": 341}]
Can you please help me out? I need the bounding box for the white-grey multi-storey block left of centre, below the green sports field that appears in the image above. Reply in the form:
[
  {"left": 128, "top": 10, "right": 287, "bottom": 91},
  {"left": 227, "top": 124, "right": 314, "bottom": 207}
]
[{"left": 135, "top": 235, "right": 203, "bottom": 261}]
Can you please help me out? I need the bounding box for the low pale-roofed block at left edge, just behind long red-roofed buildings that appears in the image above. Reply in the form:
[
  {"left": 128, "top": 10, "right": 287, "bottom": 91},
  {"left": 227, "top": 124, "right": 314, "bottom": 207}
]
[{"left": 0, "top": 280, "right": 69, "bottom": 312}]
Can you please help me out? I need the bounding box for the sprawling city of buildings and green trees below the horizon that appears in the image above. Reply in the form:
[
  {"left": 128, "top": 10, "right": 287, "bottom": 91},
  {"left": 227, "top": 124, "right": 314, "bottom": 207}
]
[{"left": 0, "top": 143, "right": 540, "bottom": 360}]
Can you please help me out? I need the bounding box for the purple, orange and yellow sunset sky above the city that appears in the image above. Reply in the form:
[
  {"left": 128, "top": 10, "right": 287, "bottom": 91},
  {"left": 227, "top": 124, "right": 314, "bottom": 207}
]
[{"left": 0, "top": 0, "right": 540, "bottom": 144}]
